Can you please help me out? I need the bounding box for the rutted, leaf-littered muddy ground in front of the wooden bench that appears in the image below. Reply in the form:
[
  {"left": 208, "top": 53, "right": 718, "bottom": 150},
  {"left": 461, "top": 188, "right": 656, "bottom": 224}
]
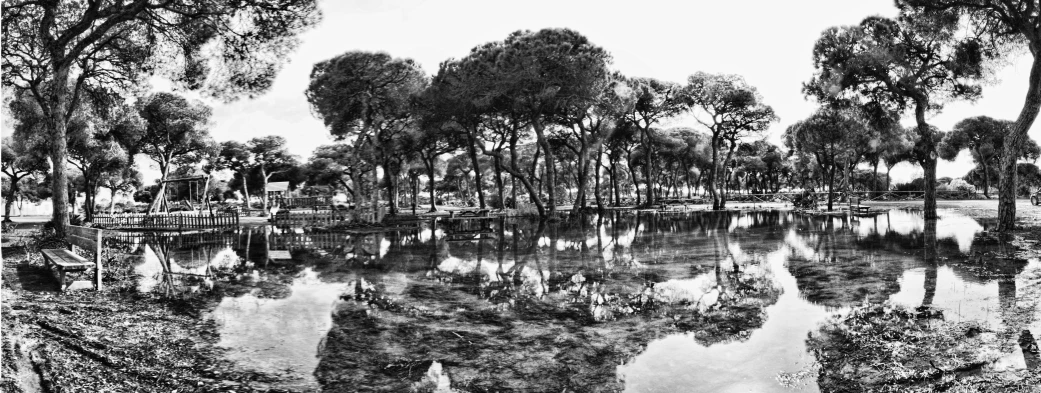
[{"left": 0, "top": 247, "right": 299, "bottom": 392}]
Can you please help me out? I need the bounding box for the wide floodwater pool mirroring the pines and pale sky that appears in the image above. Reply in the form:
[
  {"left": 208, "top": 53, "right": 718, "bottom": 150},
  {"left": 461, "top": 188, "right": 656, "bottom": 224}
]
[{"left": 109, "top": 210, "right": 1041, "bottom": 392}]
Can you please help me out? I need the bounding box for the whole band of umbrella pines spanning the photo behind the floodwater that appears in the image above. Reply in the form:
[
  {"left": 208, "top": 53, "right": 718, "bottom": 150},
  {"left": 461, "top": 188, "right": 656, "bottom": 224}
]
[{"left": 3, "top": 0, "right": 1041, "bottom": 230}]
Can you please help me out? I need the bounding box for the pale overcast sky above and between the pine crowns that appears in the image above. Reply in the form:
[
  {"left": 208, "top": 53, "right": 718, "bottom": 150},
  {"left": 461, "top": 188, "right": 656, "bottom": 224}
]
[{"left": 99, "top": 0, "right": 1039, "bottom": 181}]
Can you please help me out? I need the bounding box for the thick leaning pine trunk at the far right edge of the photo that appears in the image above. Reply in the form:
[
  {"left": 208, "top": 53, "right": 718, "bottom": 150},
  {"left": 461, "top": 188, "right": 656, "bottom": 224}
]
[{"left": 997, "top": 53, "right": 1041, "bottom": 232}]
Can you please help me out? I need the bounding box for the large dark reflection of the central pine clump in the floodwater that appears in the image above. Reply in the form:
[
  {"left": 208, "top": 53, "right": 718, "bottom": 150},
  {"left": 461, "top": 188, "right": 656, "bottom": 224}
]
[{"left": 316, "top": 212, "right": 783, "bottom": 391}]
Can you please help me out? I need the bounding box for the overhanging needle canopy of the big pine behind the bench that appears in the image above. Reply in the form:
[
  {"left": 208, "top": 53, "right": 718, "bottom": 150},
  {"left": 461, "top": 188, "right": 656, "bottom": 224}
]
[{"left": 2, "top": 0, "right": 321, "bottom": 101}]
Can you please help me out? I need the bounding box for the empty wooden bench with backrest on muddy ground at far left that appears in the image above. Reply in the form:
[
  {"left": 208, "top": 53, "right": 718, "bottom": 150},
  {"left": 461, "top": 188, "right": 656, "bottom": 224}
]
[{"left": 40, "top": 226, "right": 102, "bottom": 292}]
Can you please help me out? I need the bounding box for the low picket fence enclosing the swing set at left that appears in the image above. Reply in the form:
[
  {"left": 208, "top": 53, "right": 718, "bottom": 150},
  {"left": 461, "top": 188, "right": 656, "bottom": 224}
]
[{"left": 94, "top": 212, "right": 238, "bottom": 231}]
